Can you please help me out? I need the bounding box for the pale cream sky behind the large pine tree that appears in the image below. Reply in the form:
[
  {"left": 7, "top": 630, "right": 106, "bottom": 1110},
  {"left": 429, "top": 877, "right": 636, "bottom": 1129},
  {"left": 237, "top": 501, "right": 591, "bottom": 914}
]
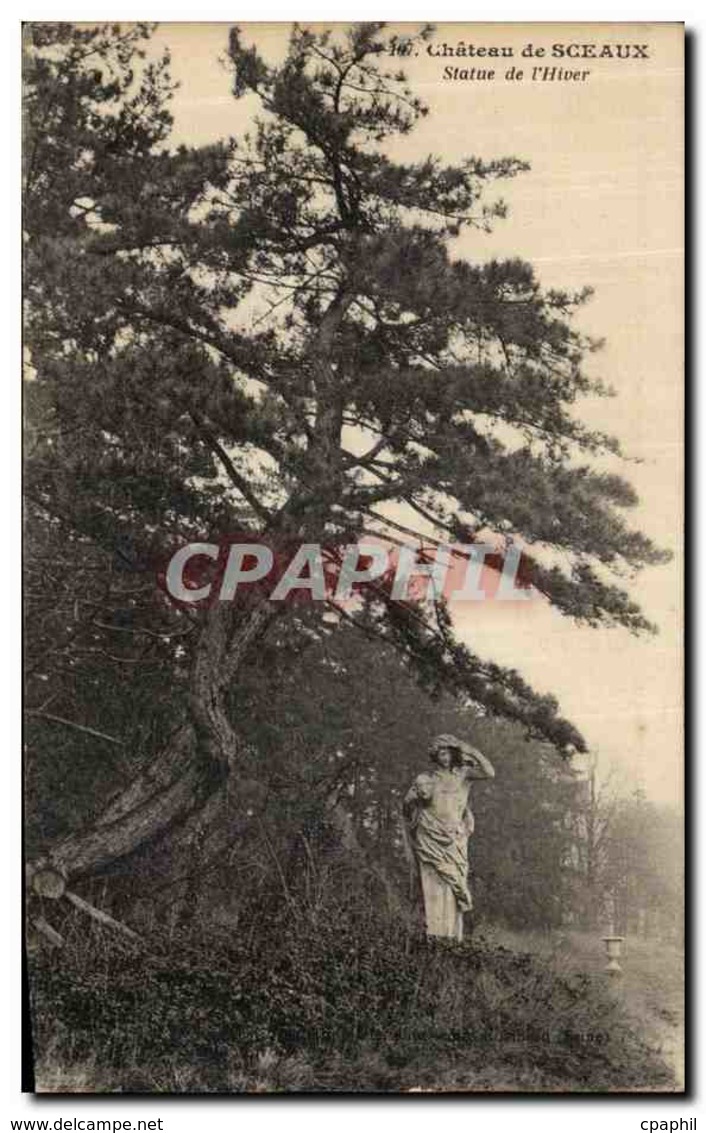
[{"left": 147, "top": 24, "right": 683, "bottom": 803}]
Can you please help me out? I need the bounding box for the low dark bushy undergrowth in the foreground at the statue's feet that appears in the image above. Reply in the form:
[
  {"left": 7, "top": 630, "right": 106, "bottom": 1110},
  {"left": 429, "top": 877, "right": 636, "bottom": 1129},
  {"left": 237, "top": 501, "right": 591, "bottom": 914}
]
[{"left": 32, "top": 874, "right": 670, "bottom": 1092}]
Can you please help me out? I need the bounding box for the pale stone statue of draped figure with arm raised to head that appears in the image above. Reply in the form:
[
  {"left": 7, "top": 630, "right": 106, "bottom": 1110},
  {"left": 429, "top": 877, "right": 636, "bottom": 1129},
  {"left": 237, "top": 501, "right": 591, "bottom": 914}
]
[{"left": 403, "top": 735, "right": 495, "bottom": 940}]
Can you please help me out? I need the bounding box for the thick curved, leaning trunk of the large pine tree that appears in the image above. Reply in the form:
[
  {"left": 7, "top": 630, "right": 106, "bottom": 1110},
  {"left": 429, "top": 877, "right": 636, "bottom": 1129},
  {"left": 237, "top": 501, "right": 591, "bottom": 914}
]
[{"left": 29, "top": 290, "right": 352, "bottom": 910}]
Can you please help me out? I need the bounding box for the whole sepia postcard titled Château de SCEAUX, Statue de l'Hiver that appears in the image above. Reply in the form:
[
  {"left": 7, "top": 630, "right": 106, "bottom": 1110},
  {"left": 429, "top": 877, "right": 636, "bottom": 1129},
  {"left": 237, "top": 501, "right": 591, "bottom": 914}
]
[{"left": 23, "top": 23, "right": 684, "bottom": 1092}]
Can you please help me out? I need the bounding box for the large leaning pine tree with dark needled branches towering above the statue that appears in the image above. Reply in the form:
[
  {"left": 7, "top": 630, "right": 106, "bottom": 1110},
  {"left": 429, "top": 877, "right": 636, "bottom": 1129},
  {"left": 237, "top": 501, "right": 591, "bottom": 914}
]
[{"left": 24, "top": 24, "right": 664, "bottom": 906}]
